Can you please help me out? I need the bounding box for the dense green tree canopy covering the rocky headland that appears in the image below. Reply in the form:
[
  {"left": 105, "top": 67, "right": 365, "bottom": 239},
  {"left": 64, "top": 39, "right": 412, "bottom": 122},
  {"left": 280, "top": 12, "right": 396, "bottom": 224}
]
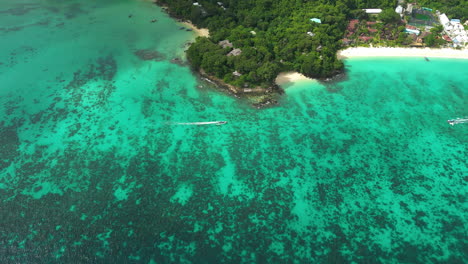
[{"left": 158, "top": 0, "right": 464, "bottom": 87}]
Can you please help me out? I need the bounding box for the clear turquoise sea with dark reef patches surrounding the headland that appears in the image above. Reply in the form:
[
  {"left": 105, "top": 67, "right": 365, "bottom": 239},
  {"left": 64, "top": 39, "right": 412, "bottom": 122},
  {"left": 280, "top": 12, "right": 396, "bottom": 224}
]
[{"left": 0, "top": 0, "right": 468, "bottom": 263}]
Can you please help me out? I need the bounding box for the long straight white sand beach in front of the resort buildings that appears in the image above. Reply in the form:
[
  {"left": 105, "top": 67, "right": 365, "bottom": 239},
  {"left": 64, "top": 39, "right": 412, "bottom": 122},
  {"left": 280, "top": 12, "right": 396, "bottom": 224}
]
[{"left": 337, "top": 47, "right": 468, "bottom": 59}]
